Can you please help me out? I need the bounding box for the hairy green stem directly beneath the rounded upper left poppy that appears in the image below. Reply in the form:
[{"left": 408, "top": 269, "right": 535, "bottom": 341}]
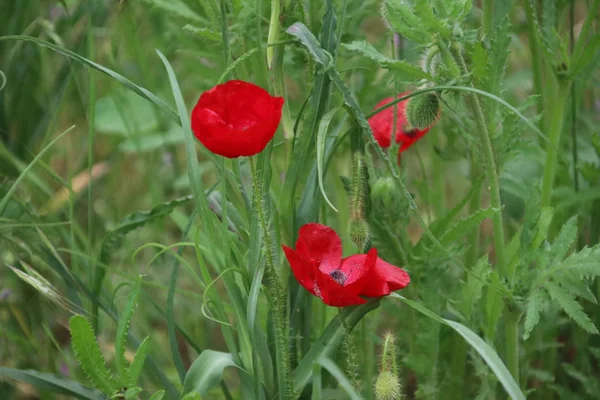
[{"left": 250, "top": 157, "right": 292, "bottom": 399}]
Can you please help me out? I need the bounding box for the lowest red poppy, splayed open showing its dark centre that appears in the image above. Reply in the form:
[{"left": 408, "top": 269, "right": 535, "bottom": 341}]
[{"left": 282, "top": 223, "right": 410, "bottom": 307}]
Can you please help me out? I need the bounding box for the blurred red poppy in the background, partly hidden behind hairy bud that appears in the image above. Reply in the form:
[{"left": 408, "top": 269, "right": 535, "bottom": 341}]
[{"left": 369, "top": 92, "right": 429, "bottom": 153}]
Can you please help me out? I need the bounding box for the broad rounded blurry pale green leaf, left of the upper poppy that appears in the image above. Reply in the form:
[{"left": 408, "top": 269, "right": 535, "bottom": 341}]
[{"left": 94, "top": 89, "right": 158, "bottom": 136}]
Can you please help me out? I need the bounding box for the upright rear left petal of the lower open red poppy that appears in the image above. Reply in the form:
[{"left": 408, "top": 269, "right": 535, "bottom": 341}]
[{"left": 296, "top": 223, "right": 342, "bottom": 274}]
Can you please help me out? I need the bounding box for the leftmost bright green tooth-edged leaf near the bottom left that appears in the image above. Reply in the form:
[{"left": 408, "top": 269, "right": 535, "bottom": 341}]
[{"left": 69, "top": 315, "right": 119, "bottom": 394}]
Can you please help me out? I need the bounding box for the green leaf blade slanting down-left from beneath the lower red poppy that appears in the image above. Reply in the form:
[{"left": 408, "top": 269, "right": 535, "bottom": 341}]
[{"left": 294, "top": 300, "right": 379, "bottom": 393}]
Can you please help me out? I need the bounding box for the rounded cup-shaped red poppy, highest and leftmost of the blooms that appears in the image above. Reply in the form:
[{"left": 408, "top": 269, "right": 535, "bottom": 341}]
[{"left": 192, "top": 80, "right": 283, "bottom": 158}]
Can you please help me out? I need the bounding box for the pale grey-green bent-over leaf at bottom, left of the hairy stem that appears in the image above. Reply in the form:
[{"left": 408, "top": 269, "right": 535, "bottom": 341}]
[{"left": 181, "top": 350, "right": 239, "bottom": 396}]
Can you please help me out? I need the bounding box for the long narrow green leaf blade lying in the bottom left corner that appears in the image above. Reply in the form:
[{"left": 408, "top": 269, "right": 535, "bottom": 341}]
[{"left": 0, "top": 368, "right": 106, "bottom": 400}]
